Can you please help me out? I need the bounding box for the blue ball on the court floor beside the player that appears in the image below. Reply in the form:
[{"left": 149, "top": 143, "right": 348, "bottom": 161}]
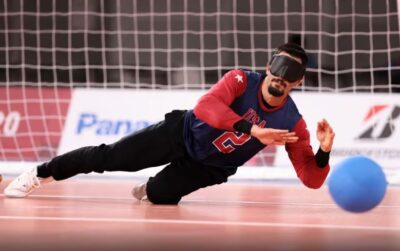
[{"left": 328, "top": 156, "right": 387, "bottom": 213}]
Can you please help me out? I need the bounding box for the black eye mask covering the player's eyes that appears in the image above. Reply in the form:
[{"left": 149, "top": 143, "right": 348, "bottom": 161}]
[{"left": 269, "top": 55, "right": 306, "bottom": 82}]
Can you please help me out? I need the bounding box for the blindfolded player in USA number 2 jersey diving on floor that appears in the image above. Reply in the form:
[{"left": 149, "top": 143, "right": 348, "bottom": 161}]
[{"left": 4, "top": 44, "right": 335, "bottom": 204}]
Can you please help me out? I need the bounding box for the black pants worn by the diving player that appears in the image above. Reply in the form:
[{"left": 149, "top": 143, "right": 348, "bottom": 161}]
[{"left": 38, "top": 110, "right": 231, "bottom": 204}]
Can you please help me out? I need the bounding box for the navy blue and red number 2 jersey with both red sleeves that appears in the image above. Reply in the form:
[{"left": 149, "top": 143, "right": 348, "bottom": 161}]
[{"left": 184, "top": 70, "right": 329, "bottom": 187}]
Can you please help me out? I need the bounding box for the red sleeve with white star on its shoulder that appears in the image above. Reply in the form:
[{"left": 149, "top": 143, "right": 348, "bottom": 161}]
[{"left": 193, "top": 70, "right": 247, "bottom": 131}]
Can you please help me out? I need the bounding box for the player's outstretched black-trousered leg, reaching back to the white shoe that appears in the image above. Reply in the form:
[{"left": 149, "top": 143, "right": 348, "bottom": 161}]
[{"left": 38, "top": 111, "right": 185, "bottom": 180}]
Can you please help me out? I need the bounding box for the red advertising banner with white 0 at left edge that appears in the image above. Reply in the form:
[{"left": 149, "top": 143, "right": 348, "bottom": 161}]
[{"left": 0, "top": 87, "right": 71, "bottom": 161}]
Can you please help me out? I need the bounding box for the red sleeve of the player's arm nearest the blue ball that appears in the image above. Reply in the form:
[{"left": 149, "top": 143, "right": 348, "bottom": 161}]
[{"left": 285, "top": 118, "right": 330, "bottom": 188}]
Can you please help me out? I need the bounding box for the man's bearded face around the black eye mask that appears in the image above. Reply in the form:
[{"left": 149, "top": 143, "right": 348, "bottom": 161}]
[{"left": 266, "top": 52, "right": 303, "bottom": 97}]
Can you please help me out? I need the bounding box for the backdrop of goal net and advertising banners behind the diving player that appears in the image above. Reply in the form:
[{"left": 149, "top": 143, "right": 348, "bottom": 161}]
[{"left": 0, "top": 0, "right": 400, "bottom": 184}]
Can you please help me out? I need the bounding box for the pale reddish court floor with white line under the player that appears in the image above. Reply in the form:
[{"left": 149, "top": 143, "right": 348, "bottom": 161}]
[{"left": 0, "top": 176, "right": 400, "bottom": 251}]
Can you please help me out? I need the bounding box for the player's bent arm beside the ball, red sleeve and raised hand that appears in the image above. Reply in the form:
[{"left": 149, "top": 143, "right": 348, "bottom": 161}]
[{"left": 286, "top": 118, "right": 335, "bottom": 188}]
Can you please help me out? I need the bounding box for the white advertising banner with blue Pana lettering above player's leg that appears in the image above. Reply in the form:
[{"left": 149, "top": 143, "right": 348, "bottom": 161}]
[{"left": 58, "top": 89, "right": 203, "bottom": 154}]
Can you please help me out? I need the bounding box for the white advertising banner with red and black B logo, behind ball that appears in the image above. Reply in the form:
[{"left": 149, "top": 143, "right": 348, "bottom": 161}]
[{"left": 275, "top": 93, "right": 400, "bottom": 183}]
